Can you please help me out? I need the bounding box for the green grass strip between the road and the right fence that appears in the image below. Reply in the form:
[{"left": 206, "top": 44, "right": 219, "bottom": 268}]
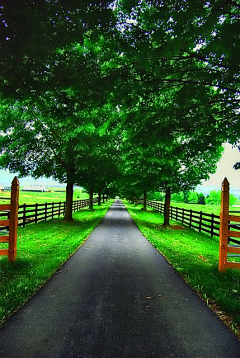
[{"left": 125, "top": 203, "right": 240, "bottom": 338}]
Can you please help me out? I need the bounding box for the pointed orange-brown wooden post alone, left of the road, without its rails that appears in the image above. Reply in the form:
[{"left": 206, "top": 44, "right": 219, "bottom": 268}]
[{"left": 8, "top": 177, "right": 19, "bottom": 261}]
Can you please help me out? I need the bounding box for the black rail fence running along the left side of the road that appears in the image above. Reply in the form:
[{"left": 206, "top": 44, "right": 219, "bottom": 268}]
[{"left": 0, "top": 198, "right": 98, "bottom": 234}]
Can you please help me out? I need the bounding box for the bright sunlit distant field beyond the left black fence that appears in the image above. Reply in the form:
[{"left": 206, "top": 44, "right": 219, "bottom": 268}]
[{"left": 0, "top": 189, "right": 88, "bottom": 205}]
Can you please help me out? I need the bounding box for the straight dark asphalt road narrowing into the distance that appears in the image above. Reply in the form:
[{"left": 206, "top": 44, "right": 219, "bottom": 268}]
[{"left": 0, "top": 201, "right": 240, "bottom": 358}]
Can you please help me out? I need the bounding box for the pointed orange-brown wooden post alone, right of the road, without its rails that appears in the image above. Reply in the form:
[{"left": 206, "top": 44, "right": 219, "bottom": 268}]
[{"left": 218, "top": 178, "right": 229, "bottom": 271}]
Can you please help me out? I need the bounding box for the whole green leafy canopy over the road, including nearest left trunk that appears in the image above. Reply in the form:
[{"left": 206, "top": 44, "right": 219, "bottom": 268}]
[{"left": 0, "top": 0, "right": 240, "bottom": 219}]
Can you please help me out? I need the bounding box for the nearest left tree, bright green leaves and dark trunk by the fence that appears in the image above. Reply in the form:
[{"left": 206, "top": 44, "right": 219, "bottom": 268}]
[{"left": 0, "top": 33, "right": 117, "bottom": 219}]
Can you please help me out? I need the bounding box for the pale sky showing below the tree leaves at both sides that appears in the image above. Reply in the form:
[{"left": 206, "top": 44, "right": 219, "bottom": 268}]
[{"left": 0, "top": 143, "right": 240, "bottom": 191}]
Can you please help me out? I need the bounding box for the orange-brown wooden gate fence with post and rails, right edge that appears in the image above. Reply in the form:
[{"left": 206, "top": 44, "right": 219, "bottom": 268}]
[{"left": 219, "top": 178, "right": 240, "bottom": 271}]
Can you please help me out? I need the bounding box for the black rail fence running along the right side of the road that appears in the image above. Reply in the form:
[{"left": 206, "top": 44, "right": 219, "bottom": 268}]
[{"left": 143, "top": 200, "right": 220, "bottom": 236}]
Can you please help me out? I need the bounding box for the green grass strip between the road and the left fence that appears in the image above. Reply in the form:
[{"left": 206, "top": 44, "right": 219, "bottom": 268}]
[{"left": 0, "top": 201, "right": 112, "bottom": 323}]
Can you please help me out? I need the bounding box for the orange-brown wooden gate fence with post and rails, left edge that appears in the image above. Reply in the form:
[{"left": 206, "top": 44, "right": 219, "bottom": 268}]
[{"left": 0, "top": 177, "right": 19, "bottom": 261}]
